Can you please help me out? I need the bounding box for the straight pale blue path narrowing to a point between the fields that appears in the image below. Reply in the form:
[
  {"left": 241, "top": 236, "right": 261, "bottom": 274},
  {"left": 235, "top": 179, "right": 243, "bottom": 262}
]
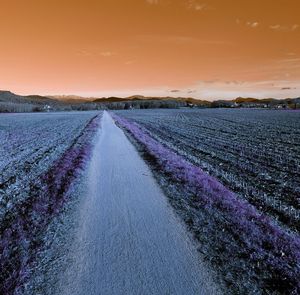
[{"left": 57, "top": 112, "right": 219, "bottom": 295}]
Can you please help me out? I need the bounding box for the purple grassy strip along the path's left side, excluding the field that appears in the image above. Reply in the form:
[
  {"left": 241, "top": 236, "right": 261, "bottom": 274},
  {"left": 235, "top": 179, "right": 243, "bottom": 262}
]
[{"left": 0, "top": 115, "right": 101, "bottom": 295}]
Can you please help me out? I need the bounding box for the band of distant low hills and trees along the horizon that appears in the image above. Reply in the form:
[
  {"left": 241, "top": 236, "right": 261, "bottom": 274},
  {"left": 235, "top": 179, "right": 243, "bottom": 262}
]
[{"left": 0, "top": 90, "right": 300, "bottom": 112}]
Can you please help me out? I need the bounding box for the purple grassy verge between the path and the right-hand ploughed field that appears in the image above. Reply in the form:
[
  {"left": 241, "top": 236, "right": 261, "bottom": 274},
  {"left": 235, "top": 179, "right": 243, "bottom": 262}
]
[{"left": 114, "top": 113, "right": 300, "bottom": 294}]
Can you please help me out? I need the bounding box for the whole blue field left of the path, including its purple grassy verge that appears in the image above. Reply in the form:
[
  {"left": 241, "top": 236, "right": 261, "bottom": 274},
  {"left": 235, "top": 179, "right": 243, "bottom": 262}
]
[{"left": 0, "top": 112, "right": 99, "bottom": 294}]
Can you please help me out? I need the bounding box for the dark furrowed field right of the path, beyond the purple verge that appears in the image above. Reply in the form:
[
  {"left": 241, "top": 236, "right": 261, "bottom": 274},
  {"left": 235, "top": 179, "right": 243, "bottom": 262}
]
[{"left": 116, "top": 110, "right": 300, "bottom": 232}]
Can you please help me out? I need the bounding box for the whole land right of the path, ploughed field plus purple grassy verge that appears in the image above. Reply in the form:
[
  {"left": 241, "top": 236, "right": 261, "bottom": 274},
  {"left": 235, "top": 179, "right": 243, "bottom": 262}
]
[{"left": 115, "top": 109, "right": 300, "bottom": 294}]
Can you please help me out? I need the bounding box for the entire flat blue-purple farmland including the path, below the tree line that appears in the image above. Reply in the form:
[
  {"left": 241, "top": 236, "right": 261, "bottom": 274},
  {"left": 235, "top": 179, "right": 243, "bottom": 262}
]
[{"left": 0, "top": 108, "right": 300, "bottom": 295}]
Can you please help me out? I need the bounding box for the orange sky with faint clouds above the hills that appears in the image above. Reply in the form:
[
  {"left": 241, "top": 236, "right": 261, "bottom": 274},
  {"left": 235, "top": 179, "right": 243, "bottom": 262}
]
[{"left": 0, "top": 0, "right": 300, "bottom": 98}]
